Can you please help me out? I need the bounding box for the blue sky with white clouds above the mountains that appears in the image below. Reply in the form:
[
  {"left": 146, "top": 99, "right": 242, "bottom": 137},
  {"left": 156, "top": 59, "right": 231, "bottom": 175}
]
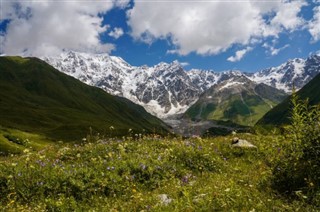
[{"left": 0, "top": 0, "right": 320, "bottom": 72}]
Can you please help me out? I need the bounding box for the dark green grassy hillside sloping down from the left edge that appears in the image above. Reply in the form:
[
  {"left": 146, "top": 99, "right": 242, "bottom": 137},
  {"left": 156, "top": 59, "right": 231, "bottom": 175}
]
[{"left": 0, "top": 57, "right": 167, "bottom": 141}]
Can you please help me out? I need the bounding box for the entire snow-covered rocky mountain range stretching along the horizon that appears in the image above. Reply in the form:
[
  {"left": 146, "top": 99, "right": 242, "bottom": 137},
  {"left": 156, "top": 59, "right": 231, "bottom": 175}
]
[{"left": 41, "top": 51, "right": 320, "bottom": 119}]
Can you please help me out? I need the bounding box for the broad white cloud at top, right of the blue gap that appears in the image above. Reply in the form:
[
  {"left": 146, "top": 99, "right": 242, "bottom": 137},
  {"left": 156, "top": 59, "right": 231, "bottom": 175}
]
[{"left": 127, "top": 0, "right": 306, "bottom": 57}]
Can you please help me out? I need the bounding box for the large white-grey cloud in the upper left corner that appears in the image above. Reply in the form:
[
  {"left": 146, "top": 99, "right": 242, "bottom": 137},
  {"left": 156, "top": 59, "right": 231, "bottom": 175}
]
[{"left": 0, "top": 0, "right": 128, "bottom": 56}]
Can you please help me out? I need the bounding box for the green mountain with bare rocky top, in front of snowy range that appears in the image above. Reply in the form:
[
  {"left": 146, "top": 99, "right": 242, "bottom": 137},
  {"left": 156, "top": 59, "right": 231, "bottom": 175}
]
[{"left": 185, "top": 78, "right": 286, "bottom": 126}]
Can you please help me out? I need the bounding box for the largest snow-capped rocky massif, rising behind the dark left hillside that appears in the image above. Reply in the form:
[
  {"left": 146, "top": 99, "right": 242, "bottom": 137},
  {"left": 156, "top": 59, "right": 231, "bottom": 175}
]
[{"left": 42, "top": 51, "right": 201, "bottom": 118}]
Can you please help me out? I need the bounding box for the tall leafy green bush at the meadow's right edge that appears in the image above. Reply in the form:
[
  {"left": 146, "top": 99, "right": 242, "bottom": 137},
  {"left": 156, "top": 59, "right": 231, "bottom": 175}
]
[{"left": 273, "top": 93, "right": 320, "bottom": 204}]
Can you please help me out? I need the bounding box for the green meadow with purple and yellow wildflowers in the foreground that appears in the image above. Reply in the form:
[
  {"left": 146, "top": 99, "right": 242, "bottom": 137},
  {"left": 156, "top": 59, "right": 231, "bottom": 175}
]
[{"left": 0, "top": 134, "right": 316, "bottom": 211}]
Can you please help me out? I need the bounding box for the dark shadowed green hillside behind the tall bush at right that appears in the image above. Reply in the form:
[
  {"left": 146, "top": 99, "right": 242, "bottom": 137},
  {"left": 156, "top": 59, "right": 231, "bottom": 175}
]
[{"left": 257, "top": 75, "right": 320, "bottom": 126}]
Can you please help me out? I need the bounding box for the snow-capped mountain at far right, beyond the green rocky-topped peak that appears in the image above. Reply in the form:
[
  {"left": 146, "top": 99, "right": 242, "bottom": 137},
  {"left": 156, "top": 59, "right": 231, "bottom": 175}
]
[{"left": 247, "top": 55, "right": 320, "bottom": 93}]
